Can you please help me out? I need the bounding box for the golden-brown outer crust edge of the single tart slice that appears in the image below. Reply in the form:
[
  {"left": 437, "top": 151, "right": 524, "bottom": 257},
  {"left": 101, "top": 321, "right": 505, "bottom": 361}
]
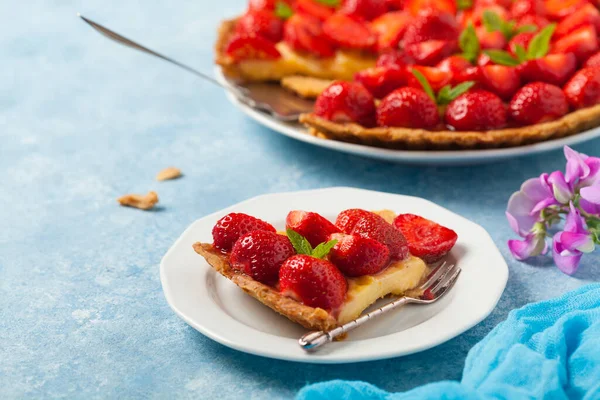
[{"left": 194, "top": 243, "right": 338, "bottom": 331}]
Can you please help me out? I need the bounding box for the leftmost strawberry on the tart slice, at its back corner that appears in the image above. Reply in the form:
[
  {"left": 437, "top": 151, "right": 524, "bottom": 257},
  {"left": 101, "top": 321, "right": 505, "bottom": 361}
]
[{"left": 212, "top": 213, "right": 275, "bottom": 251}]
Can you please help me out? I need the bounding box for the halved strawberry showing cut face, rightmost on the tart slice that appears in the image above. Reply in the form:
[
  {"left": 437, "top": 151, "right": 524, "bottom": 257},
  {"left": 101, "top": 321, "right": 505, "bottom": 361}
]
[{"left": 394, "top": 214, "right": 458, "bottom": 263}]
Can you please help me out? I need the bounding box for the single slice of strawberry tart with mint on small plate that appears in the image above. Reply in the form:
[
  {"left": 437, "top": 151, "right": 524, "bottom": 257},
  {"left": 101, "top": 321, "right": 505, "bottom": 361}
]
[{"left": 194, "top": 209, "right": 457, "bottom": 330}]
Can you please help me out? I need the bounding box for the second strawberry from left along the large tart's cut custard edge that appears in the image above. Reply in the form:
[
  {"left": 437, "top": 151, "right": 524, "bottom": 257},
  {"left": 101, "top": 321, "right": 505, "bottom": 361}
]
[{"left": 283, "top": 13, "right": 334, "bottom": 57}]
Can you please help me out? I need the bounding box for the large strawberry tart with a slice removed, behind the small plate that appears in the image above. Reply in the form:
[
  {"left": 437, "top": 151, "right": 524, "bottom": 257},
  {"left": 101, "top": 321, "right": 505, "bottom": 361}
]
[{"left": 216, "top": 0, "right": 600, "bottom": 149}]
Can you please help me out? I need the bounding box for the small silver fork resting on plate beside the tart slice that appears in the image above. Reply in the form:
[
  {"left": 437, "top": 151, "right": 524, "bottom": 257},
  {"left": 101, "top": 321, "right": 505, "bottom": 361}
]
[{"left": 298, "top": 262, "right": 461, "bottom": 352}]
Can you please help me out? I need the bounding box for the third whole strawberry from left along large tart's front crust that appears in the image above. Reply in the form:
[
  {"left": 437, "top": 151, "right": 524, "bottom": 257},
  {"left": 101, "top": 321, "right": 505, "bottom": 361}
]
[{"left": 446, "top": 90, "right": 506, "bottom": 130}]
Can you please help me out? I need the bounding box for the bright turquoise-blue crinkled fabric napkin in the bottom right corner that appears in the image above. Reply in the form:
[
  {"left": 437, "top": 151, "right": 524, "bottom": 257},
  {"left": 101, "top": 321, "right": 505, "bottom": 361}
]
[{"left": 298, "top": 284, "right": 600, "bottom": 400}]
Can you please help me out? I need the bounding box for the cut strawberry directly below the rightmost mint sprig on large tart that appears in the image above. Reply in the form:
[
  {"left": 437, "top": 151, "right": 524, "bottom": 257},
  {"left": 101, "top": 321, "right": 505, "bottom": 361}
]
[{"left": 520, "top": 53, "right": 577, "bottom": 86}]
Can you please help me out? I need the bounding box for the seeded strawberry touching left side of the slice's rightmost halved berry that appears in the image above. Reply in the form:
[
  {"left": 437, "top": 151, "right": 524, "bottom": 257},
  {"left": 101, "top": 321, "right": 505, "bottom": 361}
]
[{"left": 335, "top": 209, "right": 408, "bottom": 260}]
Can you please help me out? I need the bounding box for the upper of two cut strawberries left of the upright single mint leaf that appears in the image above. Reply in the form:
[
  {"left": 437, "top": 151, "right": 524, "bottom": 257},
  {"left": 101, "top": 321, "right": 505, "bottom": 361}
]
[{"left": 403, "top": 12, "right": 459, "bottom": 47}]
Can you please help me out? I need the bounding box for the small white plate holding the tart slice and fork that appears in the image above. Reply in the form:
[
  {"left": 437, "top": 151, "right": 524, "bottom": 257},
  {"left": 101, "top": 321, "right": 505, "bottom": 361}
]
[{"left": 160, "top": 188, "right": 508, "bottom": 363}]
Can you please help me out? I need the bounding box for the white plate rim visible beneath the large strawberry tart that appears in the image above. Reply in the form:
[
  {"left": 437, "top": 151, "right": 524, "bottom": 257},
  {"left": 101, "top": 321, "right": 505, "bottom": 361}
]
[{"left": 215, "top": 68, "right": 600, "bottom": 165}]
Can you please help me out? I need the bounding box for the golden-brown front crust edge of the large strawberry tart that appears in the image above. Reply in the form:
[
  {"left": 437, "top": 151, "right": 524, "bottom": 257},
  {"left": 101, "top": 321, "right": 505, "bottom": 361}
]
[{"left": 300, "top": 104, "right": 600, "bottom": 150}]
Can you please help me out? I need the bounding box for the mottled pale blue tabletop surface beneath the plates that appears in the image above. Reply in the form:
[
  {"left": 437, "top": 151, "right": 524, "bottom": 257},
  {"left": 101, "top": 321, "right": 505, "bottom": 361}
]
[{"left": 0, "top": 0, "right": 600, "bottom": 399}]
